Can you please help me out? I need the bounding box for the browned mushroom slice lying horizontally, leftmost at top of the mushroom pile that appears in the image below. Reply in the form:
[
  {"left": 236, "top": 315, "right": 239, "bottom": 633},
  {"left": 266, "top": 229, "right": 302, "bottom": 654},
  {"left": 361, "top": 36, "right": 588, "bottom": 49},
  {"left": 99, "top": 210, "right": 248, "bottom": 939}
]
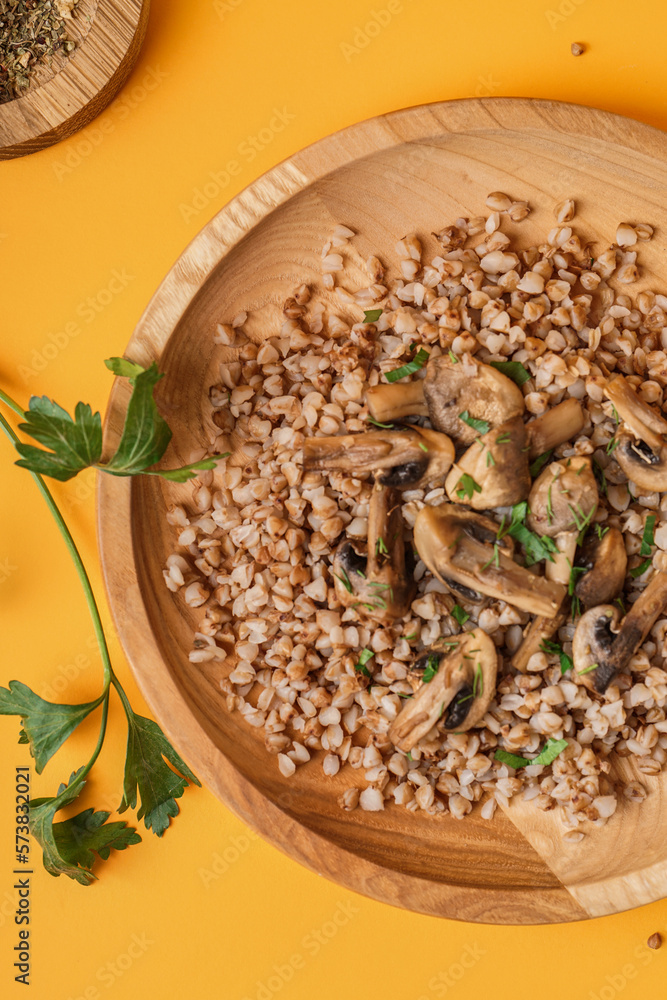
[{"left": 303, "top": 427, "right": 454, "bottom": 490}]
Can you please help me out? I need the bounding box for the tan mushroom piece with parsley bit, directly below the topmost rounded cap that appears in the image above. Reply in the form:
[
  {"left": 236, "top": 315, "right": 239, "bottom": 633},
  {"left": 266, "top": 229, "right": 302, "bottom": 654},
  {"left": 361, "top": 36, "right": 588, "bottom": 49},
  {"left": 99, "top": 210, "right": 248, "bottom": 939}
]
[{"left": 445, "top": 417, "right": 530, "bottom": 510}]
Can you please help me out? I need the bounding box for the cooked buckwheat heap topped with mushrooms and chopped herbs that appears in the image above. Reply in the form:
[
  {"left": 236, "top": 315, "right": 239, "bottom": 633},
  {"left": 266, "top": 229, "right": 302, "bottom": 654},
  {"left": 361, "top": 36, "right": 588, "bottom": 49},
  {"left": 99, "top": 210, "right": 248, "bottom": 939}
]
[{"left": 164, "top": 192, "right": 667, "bottom": 842}]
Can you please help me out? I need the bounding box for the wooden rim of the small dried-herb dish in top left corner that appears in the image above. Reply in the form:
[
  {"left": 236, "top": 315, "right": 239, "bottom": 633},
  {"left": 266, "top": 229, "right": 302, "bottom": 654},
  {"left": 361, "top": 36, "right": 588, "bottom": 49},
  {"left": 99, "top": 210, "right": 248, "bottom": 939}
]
[{"left": 0, "top": 0, "right": 150, "bottom": 160}]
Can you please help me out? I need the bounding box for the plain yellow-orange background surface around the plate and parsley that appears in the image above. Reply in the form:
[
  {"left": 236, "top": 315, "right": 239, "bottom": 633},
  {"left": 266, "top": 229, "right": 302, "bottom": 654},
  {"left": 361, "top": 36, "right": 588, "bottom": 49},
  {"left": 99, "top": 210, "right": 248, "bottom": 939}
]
[{"left": 0, "top": 0, "right": 667, "bottom": 1000}]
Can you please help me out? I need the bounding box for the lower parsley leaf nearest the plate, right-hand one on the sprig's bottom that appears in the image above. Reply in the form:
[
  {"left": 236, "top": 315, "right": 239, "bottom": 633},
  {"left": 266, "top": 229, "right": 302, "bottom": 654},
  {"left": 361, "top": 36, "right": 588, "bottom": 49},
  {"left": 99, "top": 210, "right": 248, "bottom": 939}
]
[{"left": 118, "top": 709, "right": 201, "bottom": 837}]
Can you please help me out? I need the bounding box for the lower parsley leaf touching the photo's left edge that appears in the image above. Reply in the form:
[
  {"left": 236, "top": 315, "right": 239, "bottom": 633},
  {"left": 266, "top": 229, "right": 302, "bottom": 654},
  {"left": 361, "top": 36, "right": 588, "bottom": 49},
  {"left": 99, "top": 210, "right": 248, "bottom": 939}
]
[{"left": 0, "top": 681, "right": 104, "bottom": 774}]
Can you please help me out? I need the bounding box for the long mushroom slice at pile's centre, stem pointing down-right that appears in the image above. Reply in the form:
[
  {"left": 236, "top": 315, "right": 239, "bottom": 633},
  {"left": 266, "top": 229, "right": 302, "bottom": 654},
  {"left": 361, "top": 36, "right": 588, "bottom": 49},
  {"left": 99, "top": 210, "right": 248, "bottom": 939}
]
[{"left": 414, "top": 504, "right": 566, "bottom": 618}]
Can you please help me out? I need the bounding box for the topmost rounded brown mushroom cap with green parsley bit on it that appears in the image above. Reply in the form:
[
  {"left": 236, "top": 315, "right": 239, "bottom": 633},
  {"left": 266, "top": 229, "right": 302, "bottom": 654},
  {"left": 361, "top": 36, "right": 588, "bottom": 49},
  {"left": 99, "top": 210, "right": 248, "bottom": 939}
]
[{"left": 423, "top": 354, "right": 525, "bottom": 444}]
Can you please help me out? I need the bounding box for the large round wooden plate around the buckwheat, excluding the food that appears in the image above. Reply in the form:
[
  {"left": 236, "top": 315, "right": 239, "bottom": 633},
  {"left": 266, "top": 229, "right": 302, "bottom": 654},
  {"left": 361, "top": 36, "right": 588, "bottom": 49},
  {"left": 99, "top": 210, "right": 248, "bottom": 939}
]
[{"left": 99, "top": 98, "right": 667, "bottom": 924}]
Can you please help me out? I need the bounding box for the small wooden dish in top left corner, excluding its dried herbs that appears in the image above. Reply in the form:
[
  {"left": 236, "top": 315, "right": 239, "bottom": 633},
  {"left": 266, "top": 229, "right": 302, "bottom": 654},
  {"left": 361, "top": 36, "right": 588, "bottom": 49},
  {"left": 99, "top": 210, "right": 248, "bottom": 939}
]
[{"left": 0, "top": 0, "right": 150, "bottom": 160}]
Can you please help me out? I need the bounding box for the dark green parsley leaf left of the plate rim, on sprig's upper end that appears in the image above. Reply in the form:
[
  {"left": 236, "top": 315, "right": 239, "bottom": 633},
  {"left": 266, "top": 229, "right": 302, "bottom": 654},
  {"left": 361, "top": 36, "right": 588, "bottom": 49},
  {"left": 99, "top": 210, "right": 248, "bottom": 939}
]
[{"left": 16, "top": 396, "right": 102, "bottom": 483}]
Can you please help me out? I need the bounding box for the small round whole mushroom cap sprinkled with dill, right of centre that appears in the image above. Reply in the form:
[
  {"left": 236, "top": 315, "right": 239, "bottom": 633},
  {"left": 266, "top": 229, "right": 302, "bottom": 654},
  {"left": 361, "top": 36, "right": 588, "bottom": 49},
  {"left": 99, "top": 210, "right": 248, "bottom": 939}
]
[{"left": 528, "top": 455, "right": 598, "bottom": 538}]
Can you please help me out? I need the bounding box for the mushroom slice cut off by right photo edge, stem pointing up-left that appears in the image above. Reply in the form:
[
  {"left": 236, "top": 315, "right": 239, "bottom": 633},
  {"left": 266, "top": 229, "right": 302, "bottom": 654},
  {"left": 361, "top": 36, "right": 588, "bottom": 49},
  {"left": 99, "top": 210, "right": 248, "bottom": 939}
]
[{"left": 605, "top": 375, "right": 667, "bottom": 493}]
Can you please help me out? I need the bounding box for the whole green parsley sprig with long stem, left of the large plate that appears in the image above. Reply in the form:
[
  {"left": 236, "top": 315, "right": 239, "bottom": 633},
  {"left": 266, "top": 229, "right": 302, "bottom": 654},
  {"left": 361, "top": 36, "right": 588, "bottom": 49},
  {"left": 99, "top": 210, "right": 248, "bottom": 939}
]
[{"left": 0, "top": 372, "right": 206, "bottom": 885}]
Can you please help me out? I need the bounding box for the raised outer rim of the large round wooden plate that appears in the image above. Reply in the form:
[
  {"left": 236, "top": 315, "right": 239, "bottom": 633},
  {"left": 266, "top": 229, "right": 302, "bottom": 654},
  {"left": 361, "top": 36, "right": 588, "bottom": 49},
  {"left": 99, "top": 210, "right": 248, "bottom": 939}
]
[{"left": 97, "top": 98, "right": 667, "bottom": 924}]
